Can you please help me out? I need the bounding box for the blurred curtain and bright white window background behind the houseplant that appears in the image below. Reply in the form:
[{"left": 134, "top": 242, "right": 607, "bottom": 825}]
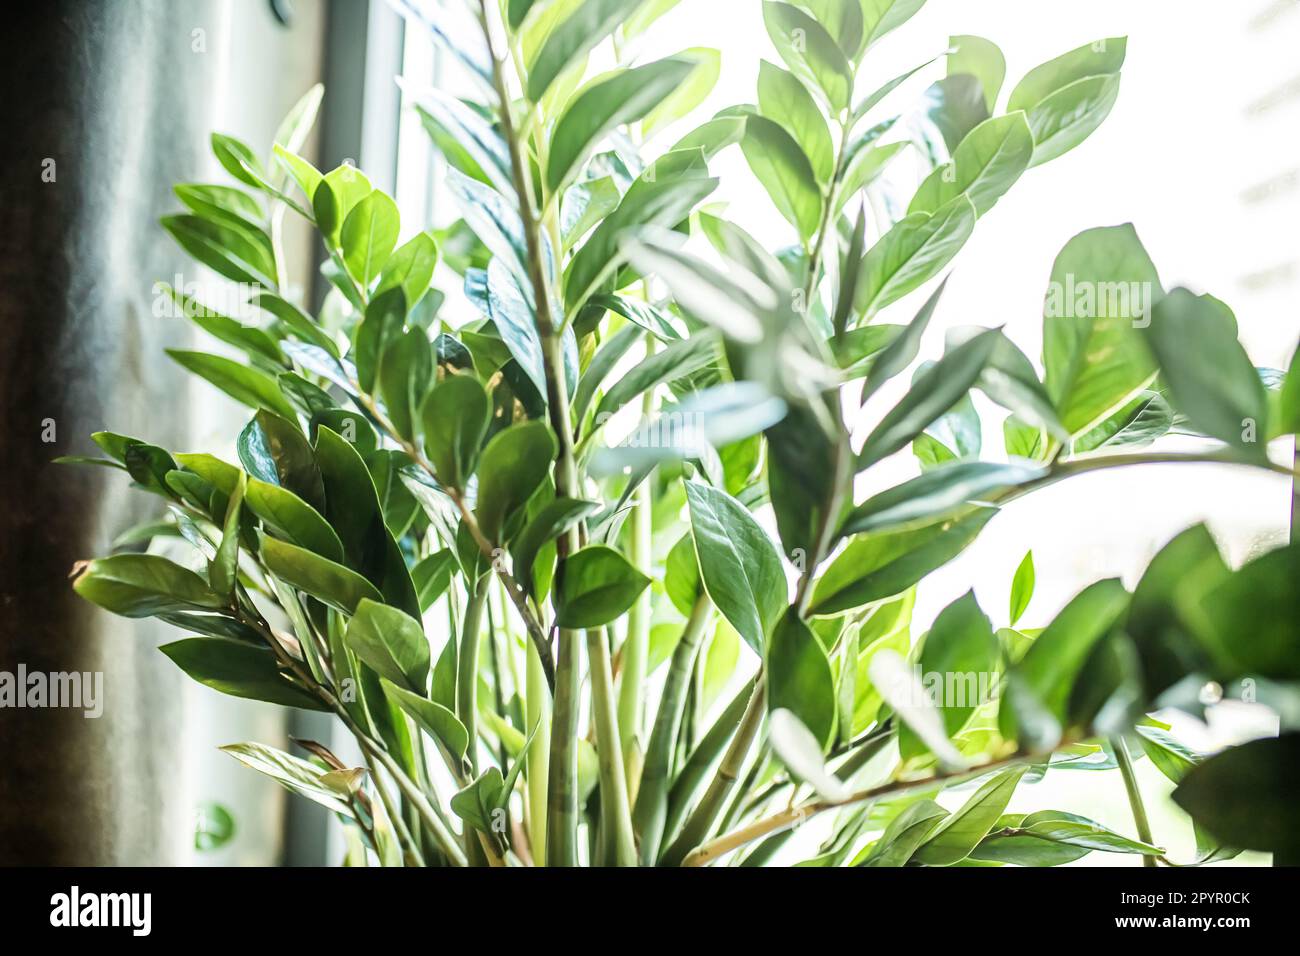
[{"left": 0, "top": 0, "right": 1300, "bottom": 865}]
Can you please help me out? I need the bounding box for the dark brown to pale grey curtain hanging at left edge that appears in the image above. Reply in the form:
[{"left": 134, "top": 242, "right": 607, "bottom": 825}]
[{"left": 0, "top": 0, "right": 330, "bottom": 865}]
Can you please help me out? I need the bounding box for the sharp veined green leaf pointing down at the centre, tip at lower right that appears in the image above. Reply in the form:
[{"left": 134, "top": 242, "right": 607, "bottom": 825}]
[{"left": 686, "top": 481, "right": 788, "bottom": 654}]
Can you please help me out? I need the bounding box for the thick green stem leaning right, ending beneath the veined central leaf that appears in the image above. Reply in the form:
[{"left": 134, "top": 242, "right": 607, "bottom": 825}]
[{"left": 632, "top": 594, "right": 712, "bottom": 866}]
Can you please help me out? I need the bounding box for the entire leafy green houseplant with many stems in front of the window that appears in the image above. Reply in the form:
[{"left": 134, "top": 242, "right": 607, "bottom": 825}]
[{"left": 65, "top": 0, "right": 1300, "bottom": 866}]
